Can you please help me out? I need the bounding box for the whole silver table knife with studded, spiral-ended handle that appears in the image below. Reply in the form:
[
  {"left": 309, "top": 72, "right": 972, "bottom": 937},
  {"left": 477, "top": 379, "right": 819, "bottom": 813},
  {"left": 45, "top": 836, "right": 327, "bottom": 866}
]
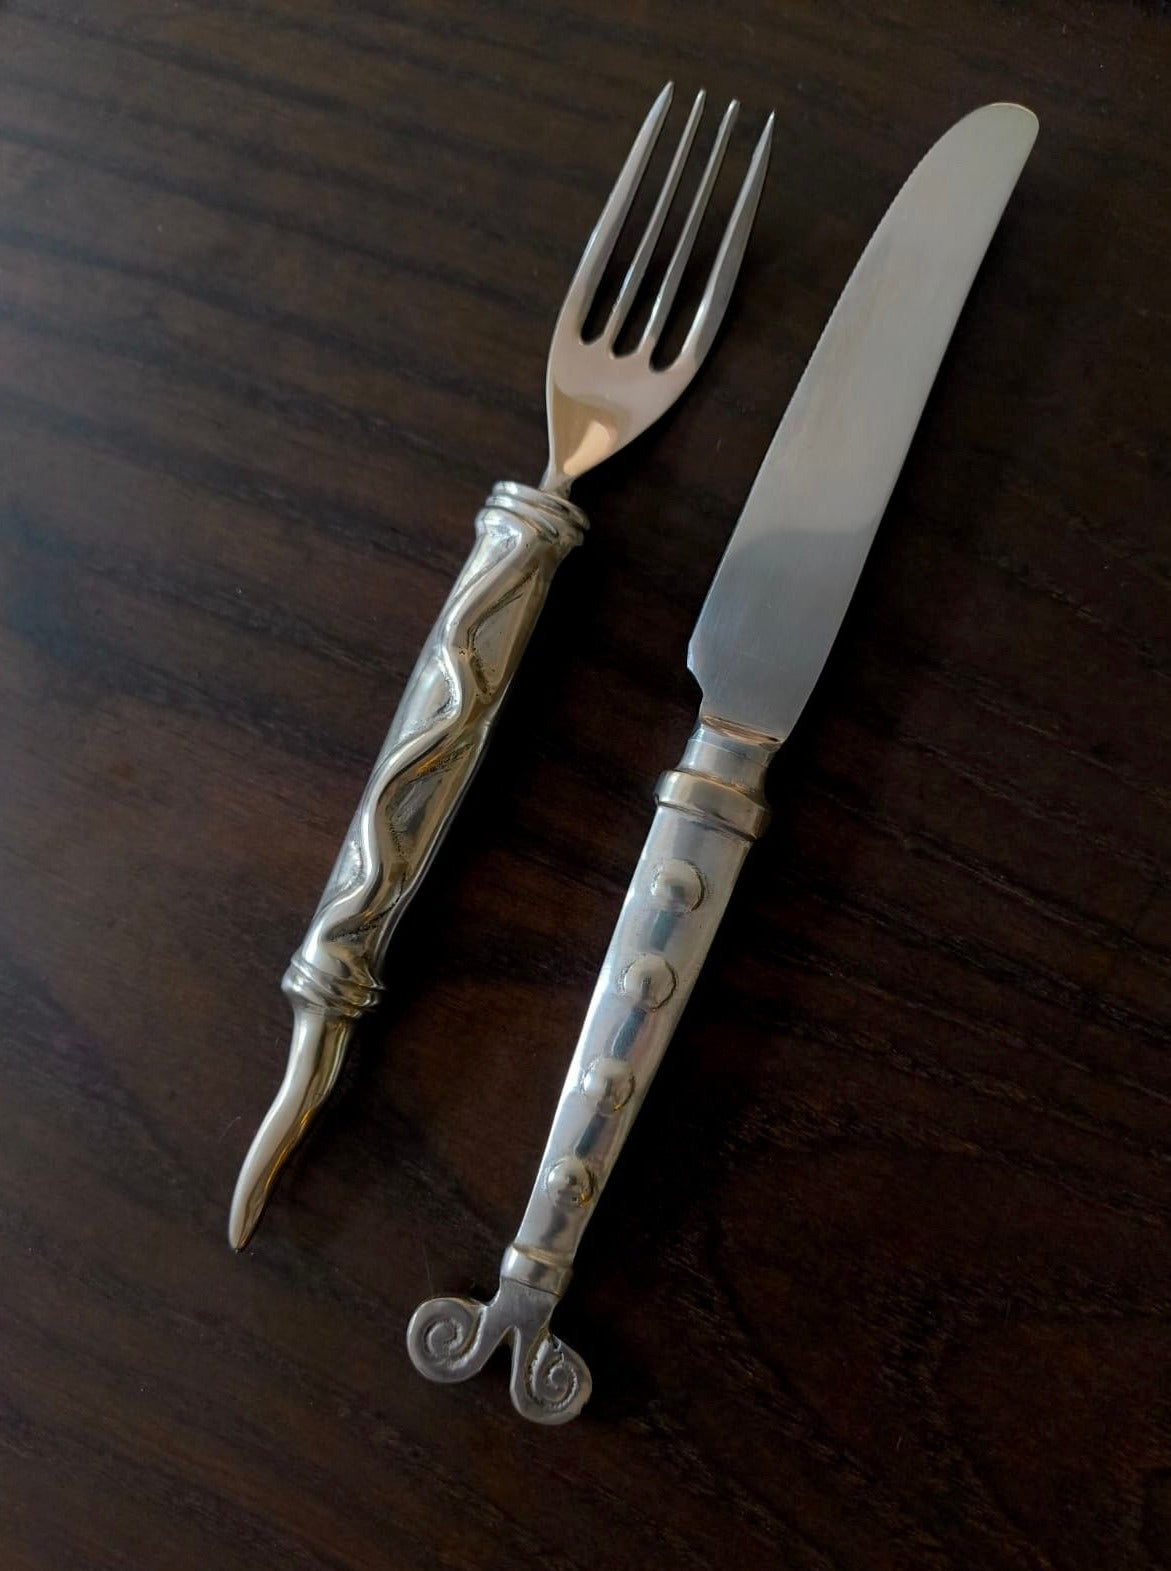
[{"left": 407, "top": 104, "right": 1037, "bottom": 1423}]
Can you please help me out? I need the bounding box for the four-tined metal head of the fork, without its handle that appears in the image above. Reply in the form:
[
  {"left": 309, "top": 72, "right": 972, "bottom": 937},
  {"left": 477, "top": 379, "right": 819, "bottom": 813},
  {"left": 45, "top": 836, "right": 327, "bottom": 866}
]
[{"left": 541, "top": 82, "right": 773, "bottom": 495}]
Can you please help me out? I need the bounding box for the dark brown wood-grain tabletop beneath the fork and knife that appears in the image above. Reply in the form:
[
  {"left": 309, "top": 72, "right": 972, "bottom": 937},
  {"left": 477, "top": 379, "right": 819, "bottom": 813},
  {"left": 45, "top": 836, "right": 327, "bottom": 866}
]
[{"left": 0, "top": 0, "right": 1171, "bottom": 1571}]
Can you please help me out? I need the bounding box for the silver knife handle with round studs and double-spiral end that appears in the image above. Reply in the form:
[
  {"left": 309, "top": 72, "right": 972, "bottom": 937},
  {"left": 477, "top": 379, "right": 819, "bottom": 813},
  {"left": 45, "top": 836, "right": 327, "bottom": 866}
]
[{"left": 407, "top": 718, "right": 778, "bottom": 1423}]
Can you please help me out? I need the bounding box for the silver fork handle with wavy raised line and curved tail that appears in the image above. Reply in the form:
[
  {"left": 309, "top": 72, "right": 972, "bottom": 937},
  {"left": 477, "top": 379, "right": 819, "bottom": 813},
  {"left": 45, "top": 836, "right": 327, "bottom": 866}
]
[{"left": 229, "top": 481, "right": 586, "bottom": 1249}]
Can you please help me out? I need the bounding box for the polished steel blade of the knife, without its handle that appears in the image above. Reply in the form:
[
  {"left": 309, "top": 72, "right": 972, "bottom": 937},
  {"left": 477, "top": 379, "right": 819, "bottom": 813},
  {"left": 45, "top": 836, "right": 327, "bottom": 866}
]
[{"left": 687, "top": 104, "right": 1037, "bottom": 742}]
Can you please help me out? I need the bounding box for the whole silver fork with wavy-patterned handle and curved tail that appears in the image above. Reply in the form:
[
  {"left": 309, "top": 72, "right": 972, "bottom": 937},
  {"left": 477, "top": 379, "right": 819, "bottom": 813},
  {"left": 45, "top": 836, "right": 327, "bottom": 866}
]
[{"left": 228, "top": 83, "right": 773, "bottom": 1249}]
